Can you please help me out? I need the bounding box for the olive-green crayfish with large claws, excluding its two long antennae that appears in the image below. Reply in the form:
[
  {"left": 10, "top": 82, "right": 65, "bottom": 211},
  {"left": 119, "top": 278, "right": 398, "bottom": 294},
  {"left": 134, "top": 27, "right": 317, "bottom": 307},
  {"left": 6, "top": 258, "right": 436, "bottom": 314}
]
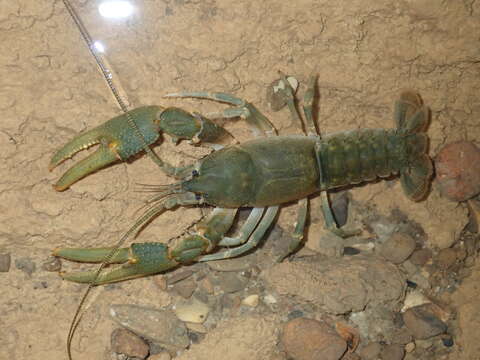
[{"left": 52, "top": 77, "right": 432, "bottom": 285}]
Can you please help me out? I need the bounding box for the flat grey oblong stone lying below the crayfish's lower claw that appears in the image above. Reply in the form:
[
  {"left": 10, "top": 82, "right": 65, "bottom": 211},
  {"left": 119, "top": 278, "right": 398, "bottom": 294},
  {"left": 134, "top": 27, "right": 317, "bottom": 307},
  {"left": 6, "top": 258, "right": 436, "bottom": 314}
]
[{"left": 110, "top": 304, "right": 190, "bottom": 351}]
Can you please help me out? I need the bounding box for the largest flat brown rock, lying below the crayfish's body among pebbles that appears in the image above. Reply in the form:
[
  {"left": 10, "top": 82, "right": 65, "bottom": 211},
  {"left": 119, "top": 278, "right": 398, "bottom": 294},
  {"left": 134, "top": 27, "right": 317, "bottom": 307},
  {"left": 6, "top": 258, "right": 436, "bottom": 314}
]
[{"left": 261, "top": 255, "right": 406, "bottom": 314}]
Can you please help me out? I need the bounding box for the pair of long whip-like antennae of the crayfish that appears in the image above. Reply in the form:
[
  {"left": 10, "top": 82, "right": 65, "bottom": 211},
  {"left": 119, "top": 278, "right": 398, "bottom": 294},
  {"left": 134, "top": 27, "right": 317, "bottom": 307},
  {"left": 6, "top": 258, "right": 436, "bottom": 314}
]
[{"left": 63, "top": 0, "right": 166, "bottom": 360}]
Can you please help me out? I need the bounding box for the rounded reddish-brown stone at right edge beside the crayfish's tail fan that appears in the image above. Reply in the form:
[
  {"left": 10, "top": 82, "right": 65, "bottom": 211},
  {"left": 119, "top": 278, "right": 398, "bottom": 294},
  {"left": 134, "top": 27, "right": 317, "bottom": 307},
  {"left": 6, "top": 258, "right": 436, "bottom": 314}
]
[{"left": 435, "top": 141, "right": 480, "bottom": 201}]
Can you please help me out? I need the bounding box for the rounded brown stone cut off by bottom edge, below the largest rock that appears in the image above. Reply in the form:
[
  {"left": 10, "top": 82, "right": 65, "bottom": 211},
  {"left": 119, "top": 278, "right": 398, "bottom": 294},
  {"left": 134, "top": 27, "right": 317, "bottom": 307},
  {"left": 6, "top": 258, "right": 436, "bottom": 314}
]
[{"left": 281, "top": 318, "right": 347, "bottom": 360}]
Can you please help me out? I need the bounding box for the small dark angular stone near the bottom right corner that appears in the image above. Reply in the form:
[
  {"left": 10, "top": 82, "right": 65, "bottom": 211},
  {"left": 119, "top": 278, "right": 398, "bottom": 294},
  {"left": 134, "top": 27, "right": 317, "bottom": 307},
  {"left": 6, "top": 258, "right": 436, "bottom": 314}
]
[{"left": 403, "top": 304, "right": 447, "bottom": 340}]
